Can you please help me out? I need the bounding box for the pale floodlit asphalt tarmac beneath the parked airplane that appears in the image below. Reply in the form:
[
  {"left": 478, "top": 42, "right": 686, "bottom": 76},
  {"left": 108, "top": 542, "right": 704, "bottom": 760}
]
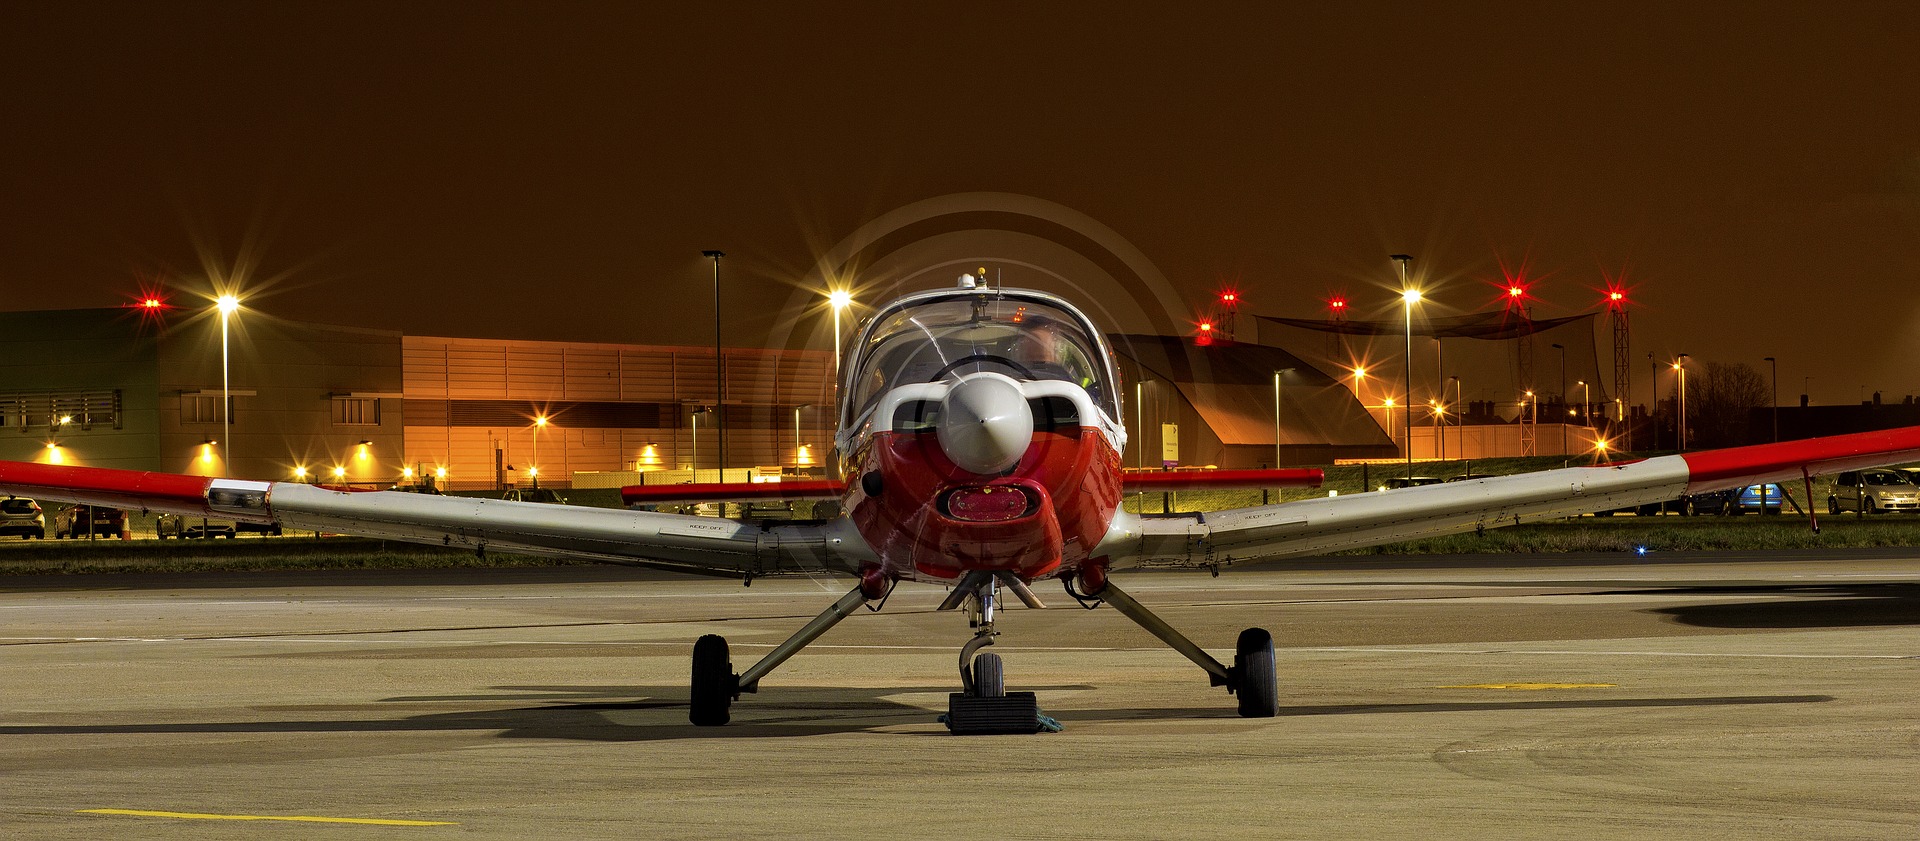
[{"left": 0, "top": 551, "right": 1920, "bottom": 839}]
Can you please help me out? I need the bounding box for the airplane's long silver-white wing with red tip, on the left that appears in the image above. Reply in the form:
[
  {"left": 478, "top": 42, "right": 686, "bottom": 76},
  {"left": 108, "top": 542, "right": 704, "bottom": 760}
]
[{"left": 0, "top": 461, "right": 872, "bottom": 576}]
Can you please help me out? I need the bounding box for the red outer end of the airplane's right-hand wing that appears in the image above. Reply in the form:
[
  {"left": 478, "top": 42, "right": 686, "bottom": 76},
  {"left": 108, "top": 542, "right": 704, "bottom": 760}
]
[{"left": 1680, "top": 426, "right": 1920, "bottom": 493}]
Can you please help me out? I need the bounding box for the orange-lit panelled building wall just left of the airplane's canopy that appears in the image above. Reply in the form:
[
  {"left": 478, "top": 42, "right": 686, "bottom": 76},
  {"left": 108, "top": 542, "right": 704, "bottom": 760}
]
[{"left": 403, "top": 336, "right": 833, "bottom": 488}]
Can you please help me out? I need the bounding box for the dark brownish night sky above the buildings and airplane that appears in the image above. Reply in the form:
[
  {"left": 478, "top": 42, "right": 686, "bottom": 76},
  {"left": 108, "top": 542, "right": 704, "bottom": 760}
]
[{"left": 11, "top": 2, "right": 1920, "bottom": 410}]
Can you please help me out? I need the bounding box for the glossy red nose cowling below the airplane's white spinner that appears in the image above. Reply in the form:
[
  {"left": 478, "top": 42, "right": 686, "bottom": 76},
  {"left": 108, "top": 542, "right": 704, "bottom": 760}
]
[{"left": 845, "top": 426, "right": 1121, "bottom": 582}]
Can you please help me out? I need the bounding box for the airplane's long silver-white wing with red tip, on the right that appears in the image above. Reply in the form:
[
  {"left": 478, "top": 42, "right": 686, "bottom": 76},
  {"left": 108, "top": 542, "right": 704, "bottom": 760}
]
[{"left": 1102, "top": 426, "right": 1920, "bottom": 568}]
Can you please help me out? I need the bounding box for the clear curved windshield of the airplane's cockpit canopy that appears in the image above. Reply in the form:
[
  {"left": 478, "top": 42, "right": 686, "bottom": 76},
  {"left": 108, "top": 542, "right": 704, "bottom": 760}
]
[{"left": 847, "top": 294, "right": 1119, "bottom": 422}]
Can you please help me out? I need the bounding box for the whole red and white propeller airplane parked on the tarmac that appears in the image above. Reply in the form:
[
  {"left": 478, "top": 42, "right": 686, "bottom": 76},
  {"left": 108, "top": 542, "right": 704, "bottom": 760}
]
[{"left": 11, "top": 276, "right": 1920, "bottom": 732}]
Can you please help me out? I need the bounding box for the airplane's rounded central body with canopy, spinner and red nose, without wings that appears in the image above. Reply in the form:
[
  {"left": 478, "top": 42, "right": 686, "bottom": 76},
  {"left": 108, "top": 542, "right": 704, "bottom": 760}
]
[{"left": 837, "top": 286, "right": 1125, "bottom": 582}]
